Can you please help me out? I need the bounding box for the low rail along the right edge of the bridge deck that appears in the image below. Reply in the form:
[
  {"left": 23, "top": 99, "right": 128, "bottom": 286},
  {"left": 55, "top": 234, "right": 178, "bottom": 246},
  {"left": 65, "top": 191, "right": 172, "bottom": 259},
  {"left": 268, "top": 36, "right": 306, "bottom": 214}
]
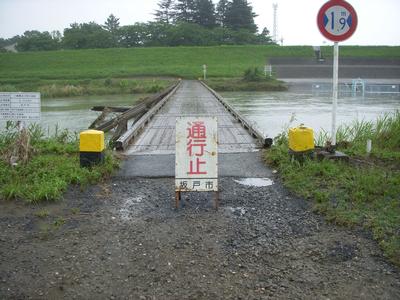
[{"left": 200, "top": 81, "right": 273, "bottom": 147}]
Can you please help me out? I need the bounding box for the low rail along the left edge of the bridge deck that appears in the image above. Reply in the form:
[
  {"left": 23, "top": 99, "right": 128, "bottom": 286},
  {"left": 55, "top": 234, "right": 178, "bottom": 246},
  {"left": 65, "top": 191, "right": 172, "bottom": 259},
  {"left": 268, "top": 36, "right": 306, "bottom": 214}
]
[{"left": 115, "top": 82, "right": 181, "bottom": 151}]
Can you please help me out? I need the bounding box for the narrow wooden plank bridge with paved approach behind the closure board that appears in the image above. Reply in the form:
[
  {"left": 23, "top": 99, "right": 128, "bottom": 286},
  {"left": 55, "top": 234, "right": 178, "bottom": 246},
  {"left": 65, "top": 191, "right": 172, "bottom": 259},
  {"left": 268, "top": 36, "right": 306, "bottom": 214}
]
[{"left": 117, "top": 80, "right": 272, "bottom": 177}]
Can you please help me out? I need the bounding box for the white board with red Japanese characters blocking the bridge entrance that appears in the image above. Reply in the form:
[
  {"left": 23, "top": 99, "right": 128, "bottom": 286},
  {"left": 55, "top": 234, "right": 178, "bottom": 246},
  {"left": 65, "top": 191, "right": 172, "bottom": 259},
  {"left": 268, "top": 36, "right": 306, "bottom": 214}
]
[{"left": 175, "top": 117, "right": 218, "bottom": 192}]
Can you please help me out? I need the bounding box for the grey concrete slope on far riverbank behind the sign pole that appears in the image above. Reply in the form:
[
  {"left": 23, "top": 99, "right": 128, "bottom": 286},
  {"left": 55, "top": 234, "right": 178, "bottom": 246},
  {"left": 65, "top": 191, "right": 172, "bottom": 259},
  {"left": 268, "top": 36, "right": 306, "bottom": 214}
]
[{"left": 269, "top": 57, "right": 400, "bottom": 81}]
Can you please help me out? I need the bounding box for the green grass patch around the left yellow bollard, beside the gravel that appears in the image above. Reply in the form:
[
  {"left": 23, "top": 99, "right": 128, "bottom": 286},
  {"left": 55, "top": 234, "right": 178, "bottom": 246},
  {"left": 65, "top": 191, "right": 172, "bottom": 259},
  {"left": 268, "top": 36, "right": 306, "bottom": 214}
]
[{"left": 0, "top": 123, "right": 118, "bottom": 203}]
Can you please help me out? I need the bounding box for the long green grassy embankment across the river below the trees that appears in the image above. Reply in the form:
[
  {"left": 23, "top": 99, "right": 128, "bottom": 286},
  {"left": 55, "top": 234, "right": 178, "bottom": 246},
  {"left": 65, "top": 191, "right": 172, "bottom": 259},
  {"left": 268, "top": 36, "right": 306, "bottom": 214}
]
[{"left": 0, "top": 46, "right": 400, "bottom": 97}]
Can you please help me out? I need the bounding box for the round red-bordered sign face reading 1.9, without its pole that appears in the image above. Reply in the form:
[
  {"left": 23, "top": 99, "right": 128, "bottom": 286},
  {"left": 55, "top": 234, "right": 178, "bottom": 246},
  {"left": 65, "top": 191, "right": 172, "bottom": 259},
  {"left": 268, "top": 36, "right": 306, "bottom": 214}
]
[{"left": 317, "top": 0, "right": 358, "bottom": 42}]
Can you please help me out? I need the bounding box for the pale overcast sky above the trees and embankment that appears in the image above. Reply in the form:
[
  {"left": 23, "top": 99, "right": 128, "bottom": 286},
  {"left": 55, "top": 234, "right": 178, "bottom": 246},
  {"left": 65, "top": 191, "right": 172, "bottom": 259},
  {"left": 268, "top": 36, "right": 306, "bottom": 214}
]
[{"left": 0, "top": 0, "right": 400, "bottom": 45}]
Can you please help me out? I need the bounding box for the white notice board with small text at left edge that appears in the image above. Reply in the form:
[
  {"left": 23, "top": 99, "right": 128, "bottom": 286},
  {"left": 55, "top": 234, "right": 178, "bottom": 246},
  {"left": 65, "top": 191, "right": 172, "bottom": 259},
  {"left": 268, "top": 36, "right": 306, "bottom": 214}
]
[{"left": 0, "top": 93, "right": 40, "bottom": 121}]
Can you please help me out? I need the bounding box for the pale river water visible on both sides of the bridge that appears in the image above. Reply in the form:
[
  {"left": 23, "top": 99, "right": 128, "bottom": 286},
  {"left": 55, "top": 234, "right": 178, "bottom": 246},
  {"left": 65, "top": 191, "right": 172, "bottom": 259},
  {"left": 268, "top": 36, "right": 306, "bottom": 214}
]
[{"left": 2, "top": 92, "right": 400, "bottom": 137}]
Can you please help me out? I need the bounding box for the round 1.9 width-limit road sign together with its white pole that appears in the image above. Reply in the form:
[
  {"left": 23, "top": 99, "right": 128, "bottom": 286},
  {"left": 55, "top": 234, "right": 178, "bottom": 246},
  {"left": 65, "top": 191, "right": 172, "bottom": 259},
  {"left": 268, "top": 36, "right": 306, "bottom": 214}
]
[{"left": 317, "top": 0, "right": 358, "bottom": 148}]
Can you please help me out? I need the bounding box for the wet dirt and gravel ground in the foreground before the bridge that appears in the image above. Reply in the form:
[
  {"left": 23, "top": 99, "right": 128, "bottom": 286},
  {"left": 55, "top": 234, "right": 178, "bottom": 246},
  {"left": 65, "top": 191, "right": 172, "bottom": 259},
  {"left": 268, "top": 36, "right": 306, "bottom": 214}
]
[{"left": 0, "top": 177, "right": 400, "bottom": 299}]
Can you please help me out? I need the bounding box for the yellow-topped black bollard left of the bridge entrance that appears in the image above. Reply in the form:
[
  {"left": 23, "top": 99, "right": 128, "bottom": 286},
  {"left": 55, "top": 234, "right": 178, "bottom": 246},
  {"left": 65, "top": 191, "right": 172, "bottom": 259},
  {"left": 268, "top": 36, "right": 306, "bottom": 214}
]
[{"left": 79, "top": 130, "right": 105, "bottom": 167}]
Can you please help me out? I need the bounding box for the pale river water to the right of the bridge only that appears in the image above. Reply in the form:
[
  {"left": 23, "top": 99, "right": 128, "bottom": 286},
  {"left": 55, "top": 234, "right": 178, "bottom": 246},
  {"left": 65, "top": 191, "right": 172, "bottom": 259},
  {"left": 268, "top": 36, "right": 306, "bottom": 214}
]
[{"left": 222, "top": 92, "right": 400, "bottom": 137}]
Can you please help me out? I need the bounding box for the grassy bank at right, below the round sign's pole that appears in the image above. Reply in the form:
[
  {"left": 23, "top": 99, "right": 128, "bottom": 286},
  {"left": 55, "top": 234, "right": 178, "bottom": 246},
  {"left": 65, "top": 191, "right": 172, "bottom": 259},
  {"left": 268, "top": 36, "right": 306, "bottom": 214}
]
[{"left": 265, "top": 111, "right": 400, "bottom": 265}]
